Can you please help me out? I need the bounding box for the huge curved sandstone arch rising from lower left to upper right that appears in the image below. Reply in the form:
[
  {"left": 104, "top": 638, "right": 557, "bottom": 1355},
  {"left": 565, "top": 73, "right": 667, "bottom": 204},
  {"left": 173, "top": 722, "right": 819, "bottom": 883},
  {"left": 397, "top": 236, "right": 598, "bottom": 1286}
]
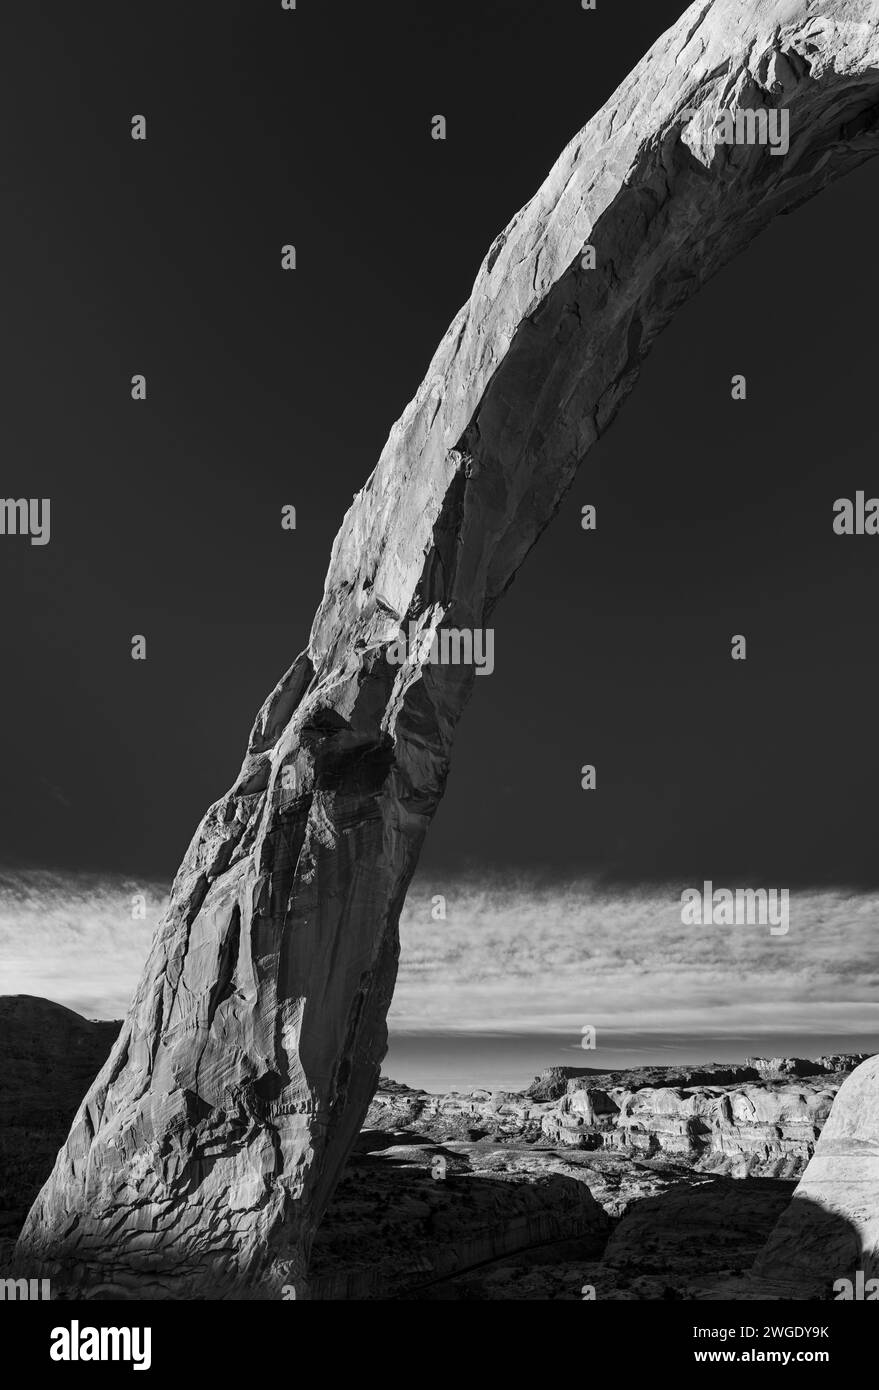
[{"left": 18, "top": 0, "right": 879, "bottom": 1298}]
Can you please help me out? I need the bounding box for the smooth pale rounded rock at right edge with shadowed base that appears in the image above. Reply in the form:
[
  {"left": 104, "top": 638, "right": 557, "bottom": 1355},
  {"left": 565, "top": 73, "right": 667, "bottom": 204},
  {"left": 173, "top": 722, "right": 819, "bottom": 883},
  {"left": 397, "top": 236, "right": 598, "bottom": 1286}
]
[{"left": 754, "top": 1056, "right": 879, "bottom": 1298}]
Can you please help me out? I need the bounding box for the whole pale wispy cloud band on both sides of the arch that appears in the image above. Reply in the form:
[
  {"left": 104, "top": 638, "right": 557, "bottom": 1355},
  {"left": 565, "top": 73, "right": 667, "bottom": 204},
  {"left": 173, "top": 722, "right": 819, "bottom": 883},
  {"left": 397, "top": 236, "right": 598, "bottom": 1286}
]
[{"left": 0, "top": 870, "right": 879, "bottom": 1038}]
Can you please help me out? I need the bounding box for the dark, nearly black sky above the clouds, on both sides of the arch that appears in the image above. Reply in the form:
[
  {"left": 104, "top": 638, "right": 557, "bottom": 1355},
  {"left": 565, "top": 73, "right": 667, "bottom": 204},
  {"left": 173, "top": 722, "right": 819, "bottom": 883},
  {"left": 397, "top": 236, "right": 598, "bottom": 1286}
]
[{"left": 0, "top": 0, "right": 879, "bottom": 885}]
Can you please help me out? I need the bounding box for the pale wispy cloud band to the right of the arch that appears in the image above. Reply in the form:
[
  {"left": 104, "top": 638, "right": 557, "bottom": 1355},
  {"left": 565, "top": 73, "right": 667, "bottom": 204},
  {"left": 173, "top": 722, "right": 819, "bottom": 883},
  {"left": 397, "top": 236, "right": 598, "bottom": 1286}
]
[{"left": 391, "top": 878, "right": 879, "bottom": 1036}]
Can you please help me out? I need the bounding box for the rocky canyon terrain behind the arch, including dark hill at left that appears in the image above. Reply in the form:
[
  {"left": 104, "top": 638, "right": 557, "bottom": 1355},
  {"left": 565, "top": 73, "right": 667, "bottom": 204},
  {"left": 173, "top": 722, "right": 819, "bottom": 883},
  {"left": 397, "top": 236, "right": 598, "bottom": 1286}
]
[{"left": 0, "top": 997, "right": 869, "bottom": 1300}]
